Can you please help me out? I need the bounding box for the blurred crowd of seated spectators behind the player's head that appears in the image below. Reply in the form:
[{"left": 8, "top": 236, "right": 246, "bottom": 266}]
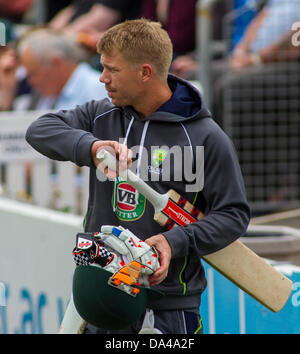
[{"left": 0, "top": 0, "right": 300, "bottom": 126}]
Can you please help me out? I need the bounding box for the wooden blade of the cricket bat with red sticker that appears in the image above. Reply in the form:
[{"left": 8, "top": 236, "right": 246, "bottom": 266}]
[{"left": 154, "top": 190, "right": 292, "bottom": 312}]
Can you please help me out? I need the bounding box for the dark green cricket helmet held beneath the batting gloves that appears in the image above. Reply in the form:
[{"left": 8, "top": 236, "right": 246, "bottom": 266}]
[{"left": 73, "top": 265, "right": 164, "bottom": 330}]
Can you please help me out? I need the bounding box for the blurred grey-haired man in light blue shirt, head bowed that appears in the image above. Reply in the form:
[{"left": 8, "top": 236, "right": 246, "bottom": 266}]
[{"left": 6, "top": 29, "right": 107, "bottom": 110}]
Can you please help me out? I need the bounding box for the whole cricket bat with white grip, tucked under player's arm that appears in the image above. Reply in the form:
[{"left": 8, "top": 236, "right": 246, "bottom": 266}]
[{"left": 97, "top": 149, "right": 293, "bottom": 312}]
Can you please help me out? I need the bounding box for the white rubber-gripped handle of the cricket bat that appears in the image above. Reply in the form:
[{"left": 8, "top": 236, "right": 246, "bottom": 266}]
[{"left": 96, "top": 149, "right": 168, "bottom": 213}]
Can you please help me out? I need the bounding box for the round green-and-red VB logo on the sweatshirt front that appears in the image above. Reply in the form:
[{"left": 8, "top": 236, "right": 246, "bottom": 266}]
[{"left": 112, "top": 177, "right": 146, "bottom": 221}]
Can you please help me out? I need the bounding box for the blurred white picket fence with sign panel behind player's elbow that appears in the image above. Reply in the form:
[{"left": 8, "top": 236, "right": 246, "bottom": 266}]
[{"left": 0, "top": 111, "right": 89, "bottom": 215}]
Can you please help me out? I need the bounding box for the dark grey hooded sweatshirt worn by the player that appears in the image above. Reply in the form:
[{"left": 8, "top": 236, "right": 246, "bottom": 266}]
[{"left": 26, "top": 75, "right": 250, "bottom": 310}]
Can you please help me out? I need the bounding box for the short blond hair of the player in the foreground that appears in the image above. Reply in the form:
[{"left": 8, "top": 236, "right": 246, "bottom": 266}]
[{"left": 97, "top": 19, "right": 173, "bottom": 80}]
